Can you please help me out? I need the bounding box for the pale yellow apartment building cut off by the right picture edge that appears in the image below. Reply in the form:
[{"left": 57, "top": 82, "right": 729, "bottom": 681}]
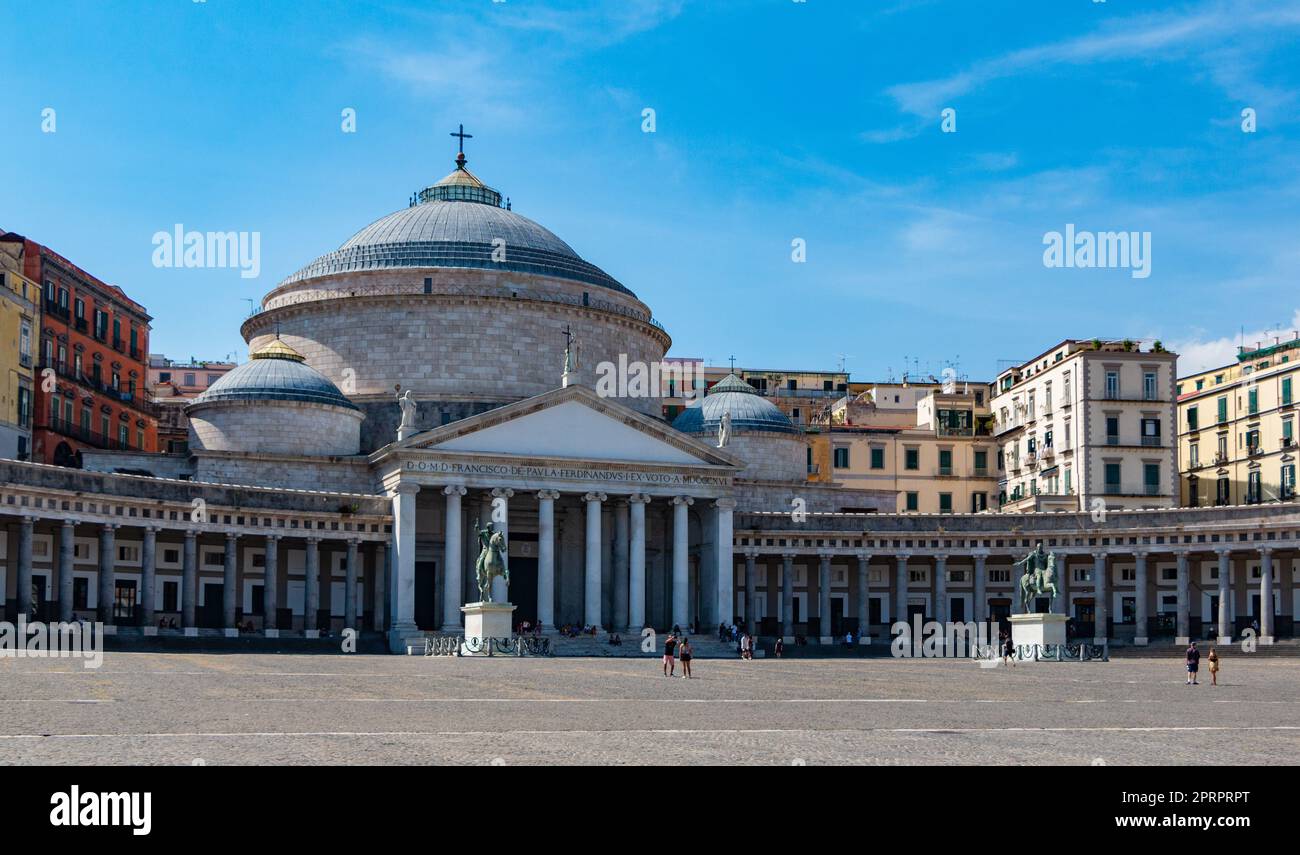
[{"left": 1178, "top": 337, "right": 1300, "bottom": 507}]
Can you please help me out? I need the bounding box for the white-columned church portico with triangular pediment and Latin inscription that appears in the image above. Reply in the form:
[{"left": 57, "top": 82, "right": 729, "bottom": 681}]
[{"left": 371, "top": 386, "right": 741, "bottom": 650}]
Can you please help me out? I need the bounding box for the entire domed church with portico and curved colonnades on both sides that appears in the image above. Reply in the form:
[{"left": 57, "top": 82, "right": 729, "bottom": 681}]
[{"left": 0, "top": 155, "right": 1300, "bottom": 651}]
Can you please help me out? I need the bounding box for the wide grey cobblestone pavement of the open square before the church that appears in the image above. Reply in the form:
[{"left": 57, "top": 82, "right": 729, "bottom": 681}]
[{"left": 0, "top": 651, "right": 1300, "bottom": 765}]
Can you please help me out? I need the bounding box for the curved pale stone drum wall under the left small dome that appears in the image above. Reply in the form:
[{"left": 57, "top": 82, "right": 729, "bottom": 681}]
[{"left": 189, "top": 400, "right": 363, "bottom": 459}]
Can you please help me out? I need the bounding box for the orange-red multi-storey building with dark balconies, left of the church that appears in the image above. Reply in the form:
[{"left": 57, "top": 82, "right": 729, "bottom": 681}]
[{"left": 0, "top": 233, "right": 159, "bottom": 466}]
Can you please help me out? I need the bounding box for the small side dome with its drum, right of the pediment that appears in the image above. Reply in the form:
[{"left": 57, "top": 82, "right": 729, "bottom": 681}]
[{"left": 672, "top": 374, "right": 807, "bottom": 483}]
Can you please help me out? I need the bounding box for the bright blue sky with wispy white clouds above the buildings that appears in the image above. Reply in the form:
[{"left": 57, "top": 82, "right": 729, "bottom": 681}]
[{"left": 0, "top": 0, "right": 1300, "bottom": 378}]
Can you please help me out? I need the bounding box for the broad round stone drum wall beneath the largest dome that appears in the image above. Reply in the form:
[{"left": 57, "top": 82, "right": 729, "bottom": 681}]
[{"left": 242, "top": 270, "right": 671, "bottom": 415}]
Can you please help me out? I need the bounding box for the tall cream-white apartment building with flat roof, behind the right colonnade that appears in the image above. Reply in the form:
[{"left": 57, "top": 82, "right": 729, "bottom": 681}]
[{"left": 992, "top": 339, "right": 1178, "bottom": 512}]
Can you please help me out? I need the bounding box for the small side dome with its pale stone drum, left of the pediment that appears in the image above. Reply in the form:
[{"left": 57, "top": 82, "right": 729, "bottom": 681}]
[{"left": 185, "top": 338, "right": 365, "bottom": 456}]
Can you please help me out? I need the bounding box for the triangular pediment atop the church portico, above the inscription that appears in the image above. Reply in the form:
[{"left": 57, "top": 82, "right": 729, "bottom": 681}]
[{"left": 377, "top": 386, "right": 741, "bottom": 466}]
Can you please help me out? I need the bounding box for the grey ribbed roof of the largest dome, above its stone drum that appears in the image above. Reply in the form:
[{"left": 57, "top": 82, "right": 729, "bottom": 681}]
[{"left": 281, "top": 156, "right": 632, "bottom": 295}]
